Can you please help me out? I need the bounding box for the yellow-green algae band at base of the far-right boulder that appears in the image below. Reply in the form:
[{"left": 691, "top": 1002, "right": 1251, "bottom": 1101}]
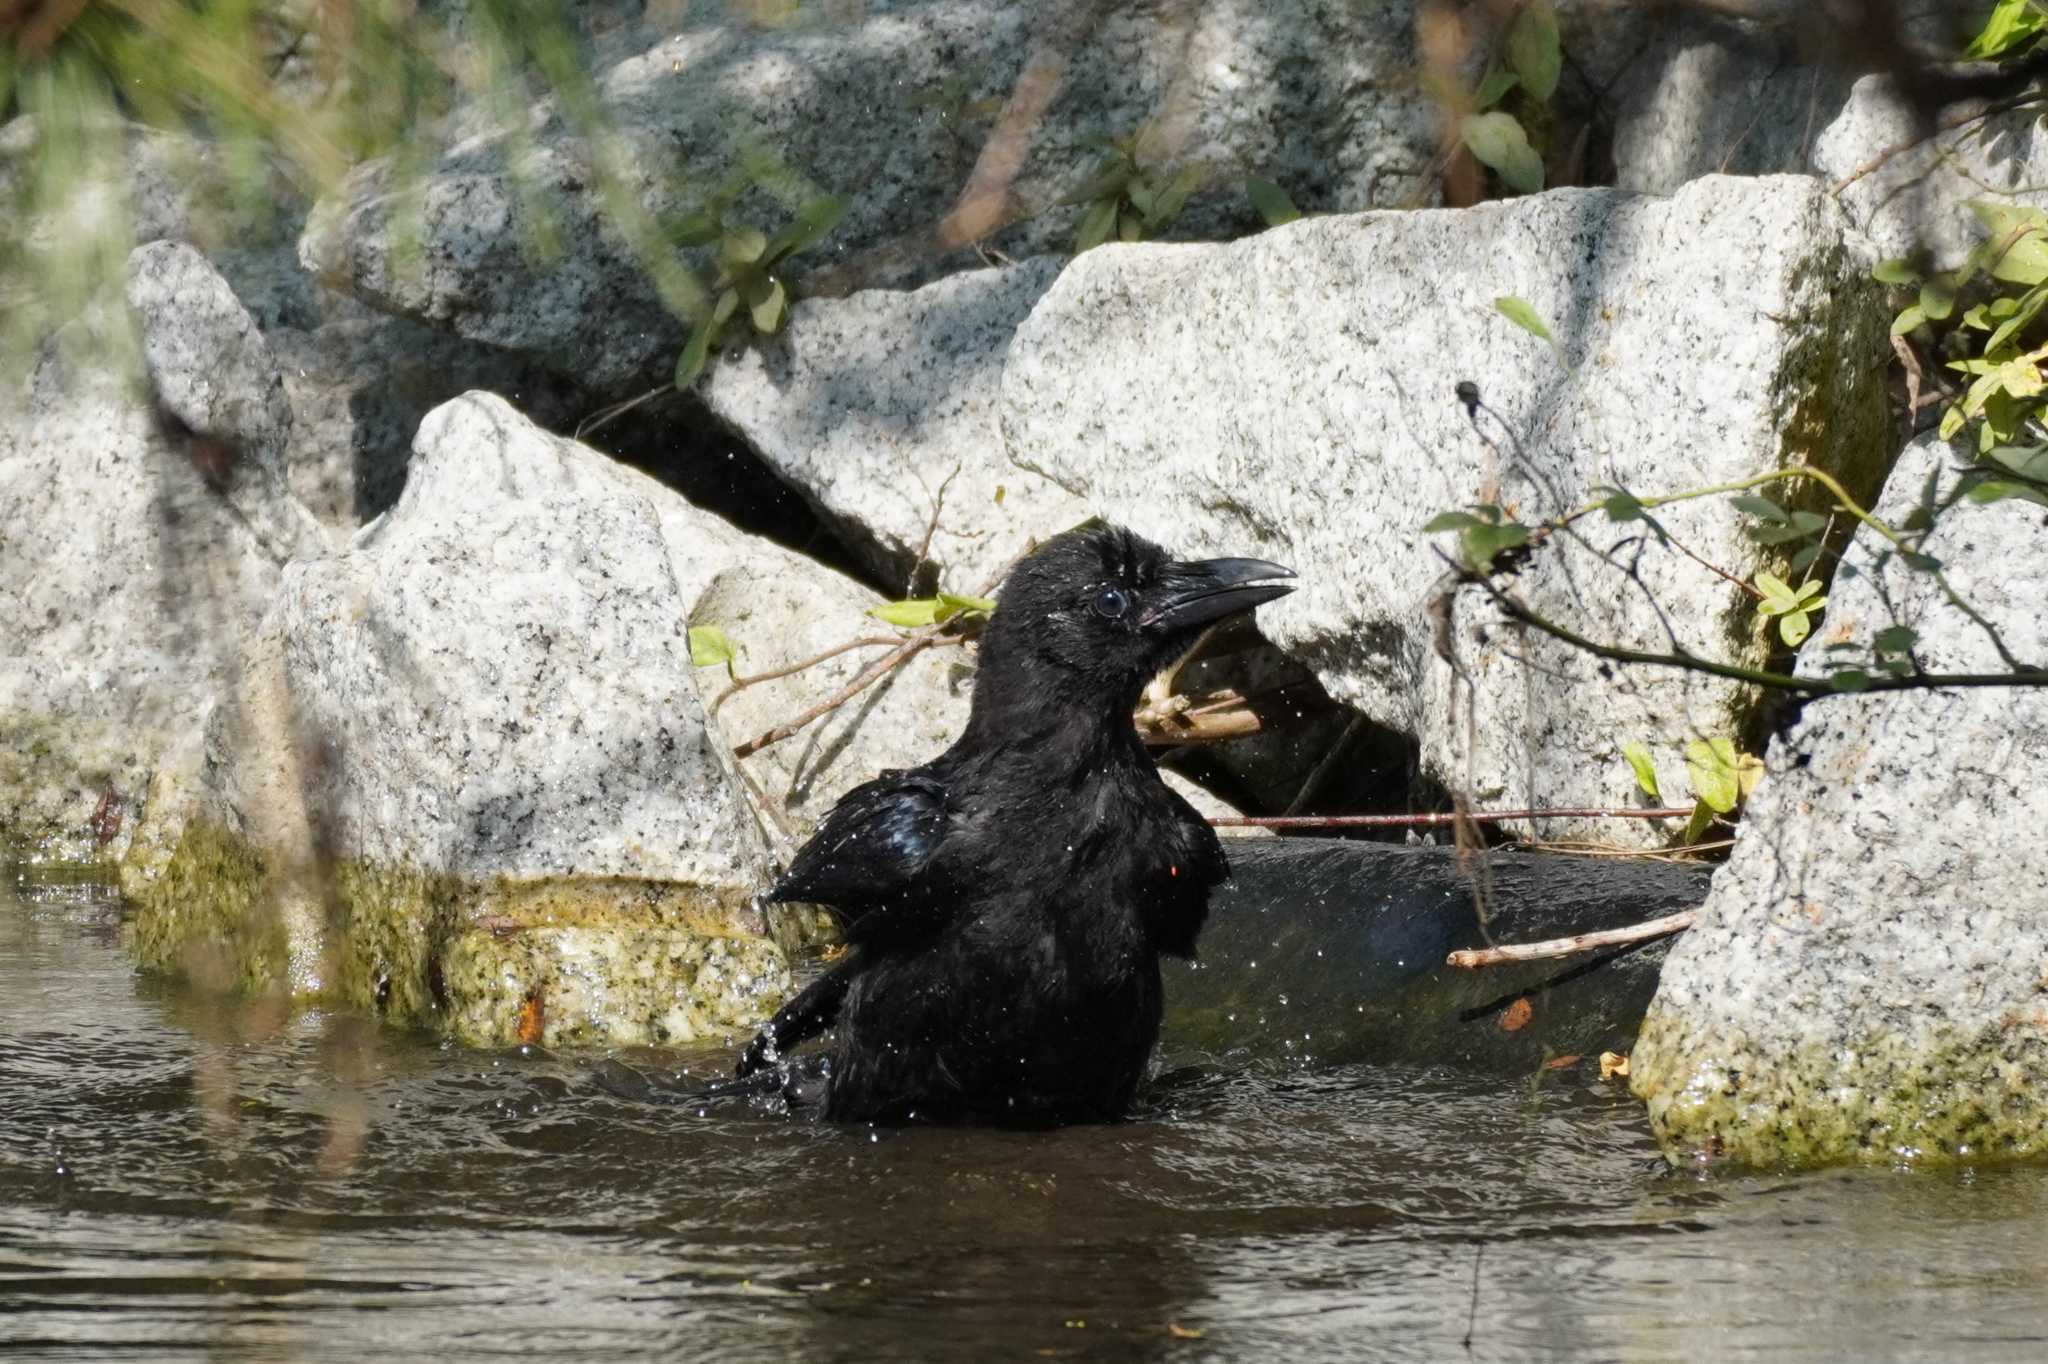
[{"left": 1630, "top": 1010, "right": 2048, "bottom": 1169}]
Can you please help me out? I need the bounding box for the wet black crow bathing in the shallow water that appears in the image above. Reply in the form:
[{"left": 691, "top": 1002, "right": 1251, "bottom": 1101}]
[{"left": 737, "top": 522, "right": 1294, "bottom": 1126}]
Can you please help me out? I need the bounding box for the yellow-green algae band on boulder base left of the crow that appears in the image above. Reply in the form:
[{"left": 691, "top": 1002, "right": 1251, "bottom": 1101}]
[{"left": 129, "top": 821, "right": 791, "bottom": 1047}]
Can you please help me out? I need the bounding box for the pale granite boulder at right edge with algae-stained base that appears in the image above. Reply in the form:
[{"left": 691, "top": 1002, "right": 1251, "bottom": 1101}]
[{"left": 1632, "top": 440, "right": 2048, "bottom": 1165}]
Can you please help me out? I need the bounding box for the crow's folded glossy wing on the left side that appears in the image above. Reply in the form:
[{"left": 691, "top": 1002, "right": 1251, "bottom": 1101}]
[{"left": 768, "top": 768, "right": 946, "bottom": 929}]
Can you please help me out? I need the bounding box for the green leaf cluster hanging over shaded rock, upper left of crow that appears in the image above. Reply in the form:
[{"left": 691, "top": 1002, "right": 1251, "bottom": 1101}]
[{"left": 674, "top": 172, "right": 846, "bottom": 389}]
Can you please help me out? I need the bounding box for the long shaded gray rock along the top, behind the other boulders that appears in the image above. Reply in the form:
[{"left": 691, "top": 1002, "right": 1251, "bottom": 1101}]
[{"left": 301, "top": 0, "right": 1436, "bottom": 387}]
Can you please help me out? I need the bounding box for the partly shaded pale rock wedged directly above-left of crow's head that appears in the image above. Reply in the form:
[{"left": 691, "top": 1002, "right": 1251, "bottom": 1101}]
[{"left": 705, "top": 256, "right": 1087, "bottom": 594}]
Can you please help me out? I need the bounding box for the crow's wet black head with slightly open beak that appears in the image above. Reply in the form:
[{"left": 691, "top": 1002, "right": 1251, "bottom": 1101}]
[{"left": 981, "top": 524, "right": 1294, "bottom": 711}]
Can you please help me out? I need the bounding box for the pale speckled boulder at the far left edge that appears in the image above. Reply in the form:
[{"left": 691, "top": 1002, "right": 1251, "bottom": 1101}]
[{"left": 0, "top": 244, "right": 326, "bottom": 864}]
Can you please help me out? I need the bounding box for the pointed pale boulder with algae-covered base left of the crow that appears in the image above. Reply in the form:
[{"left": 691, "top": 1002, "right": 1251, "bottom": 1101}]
[{"left": 133, "top": 393, "right": 823, "bottom": 1045}]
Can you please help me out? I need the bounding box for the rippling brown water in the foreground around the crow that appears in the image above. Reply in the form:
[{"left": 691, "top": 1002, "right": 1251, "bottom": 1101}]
[{"left": 0, "top": 876, "right": 2048, "bottom": 1360}]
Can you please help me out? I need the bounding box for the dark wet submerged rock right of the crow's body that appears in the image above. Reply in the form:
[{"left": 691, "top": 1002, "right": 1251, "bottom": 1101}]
[{"left": 1163, "top": 838, "right": 1708, "bottom": 1073}]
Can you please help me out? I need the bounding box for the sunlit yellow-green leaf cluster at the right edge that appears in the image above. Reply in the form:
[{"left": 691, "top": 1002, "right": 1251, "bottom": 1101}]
[{"left": 1874, "top": 201, "right": 2048, "bottom": 506}]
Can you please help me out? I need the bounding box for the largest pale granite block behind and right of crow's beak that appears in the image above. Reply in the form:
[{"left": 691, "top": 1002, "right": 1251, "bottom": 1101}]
[{"left": 1004, "top": 178, "right": 1888, "bottom": 842}]
